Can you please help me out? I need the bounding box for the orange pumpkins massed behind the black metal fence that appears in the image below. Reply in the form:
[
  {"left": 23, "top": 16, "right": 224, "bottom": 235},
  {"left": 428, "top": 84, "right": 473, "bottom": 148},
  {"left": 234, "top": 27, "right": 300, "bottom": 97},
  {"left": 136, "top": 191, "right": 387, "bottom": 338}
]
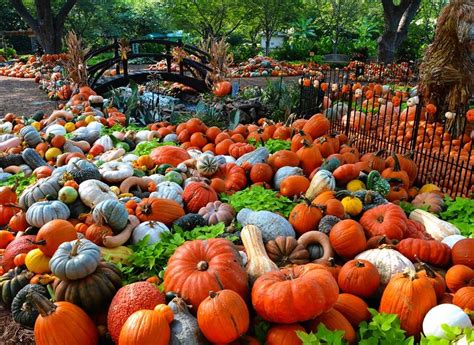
[{"left": 314, "top": 79, "right": 474, "bottom": 196}]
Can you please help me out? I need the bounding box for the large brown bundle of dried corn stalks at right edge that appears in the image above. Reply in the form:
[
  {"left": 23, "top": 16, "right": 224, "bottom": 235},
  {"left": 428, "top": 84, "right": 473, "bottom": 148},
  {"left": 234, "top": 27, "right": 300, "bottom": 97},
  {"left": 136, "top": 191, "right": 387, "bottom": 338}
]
[{"left": 419, "top": 0, "right": 474, "bottom": 136}]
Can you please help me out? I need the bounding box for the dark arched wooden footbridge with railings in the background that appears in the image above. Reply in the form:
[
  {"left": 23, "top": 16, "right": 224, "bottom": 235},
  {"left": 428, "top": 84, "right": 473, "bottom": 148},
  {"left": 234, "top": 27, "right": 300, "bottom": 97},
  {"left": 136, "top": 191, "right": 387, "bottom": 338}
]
[{"left": 85, "top": 39, "right": 211, "bottom": 94}]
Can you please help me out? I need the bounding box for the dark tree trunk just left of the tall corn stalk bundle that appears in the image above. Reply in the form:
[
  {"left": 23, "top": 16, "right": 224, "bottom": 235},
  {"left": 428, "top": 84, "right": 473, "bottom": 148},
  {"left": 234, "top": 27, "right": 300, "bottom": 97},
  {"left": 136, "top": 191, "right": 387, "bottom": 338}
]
[{"left": 378, "top": 0, "right": 421, "bottom": 64}]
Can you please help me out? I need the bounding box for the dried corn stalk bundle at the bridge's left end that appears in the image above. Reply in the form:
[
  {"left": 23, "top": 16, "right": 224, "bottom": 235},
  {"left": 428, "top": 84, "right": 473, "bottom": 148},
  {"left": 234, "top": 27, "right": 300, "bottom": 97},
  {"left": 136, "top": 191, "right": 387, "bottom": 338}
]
[{"left": 65, "top": 31, "right": 89, "bottom": 88}]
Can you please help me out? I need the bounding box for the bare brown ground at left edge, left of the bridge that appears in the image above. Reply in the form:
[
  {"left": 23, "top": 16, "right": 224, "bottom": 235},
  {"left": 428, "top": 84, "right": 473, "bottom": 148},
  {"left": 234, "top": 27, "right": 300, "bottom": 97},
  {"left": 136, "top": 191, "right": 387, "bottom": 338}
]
[{"left": 0, "top": 76, "right": 57, "bottom": 118}]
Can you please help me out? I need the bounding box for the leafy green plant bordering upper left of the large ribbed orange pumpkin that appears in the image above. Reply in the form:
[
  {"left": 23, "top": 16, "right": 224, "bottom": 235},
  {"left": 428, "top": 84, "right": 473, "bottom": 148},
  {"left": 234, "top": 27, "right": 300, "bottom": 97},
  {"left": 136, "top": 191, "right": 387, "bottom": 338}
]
[{"left": 111, "top": 223, "right": 230, "bottom": 284}]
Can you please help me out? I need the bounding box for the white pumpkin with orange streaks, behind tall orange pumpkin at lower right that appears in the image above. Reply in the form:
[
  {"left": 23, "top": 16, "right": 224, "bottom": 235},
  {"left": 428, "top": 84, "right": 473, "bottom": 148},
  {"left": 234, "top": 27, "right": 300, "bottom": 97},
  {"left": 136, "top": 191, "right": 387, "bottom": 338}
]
[{"left": 356, "top": 248, "right": 415, "bottom": 284}]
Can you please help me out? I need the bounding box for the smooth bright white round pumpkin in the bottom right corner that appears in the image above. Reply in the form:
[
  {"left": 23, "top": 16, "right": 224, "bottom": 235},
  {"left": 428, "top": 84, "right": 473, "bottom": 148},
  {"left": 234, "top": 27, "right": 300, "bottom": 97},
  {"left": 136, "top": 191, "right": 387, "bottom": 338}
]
[{"left": 423, "top": 304, "right": 472, "bottom": 338}]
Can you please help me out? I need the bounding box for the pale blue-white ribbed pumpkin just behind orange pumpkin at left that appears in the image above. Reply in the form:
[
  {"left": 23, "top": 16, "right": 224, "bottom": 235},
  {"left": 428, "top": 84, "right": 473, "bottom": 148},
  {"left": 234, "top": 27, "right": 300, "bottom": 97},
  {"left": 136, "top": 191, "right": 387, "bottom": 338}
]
[{"left": 26, "top": 200, "right": 70, "bottom": 228}]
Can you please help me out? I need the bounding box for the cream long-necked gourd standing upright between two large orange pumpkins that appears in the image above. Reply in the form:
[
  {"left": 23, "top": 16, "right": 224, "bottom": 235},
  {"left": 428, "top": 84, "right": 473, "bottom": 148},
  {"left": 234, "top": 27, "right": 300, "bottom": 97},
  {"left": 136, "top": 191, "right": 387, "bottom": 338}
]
[{"left": 240, "top": 225, "right": 278, "bottom": 283}]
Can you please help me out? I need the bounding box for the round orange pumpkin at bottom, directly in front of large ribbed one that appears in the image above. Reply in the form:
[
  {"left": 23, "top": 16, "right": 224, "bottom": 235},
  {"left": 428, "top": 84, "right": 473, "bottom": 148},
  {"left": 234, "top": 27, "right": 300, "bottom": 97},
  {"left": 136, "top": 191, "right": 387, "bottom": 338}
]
[{"left": 197, "top": 290, "right": 250, "bottom": 344}]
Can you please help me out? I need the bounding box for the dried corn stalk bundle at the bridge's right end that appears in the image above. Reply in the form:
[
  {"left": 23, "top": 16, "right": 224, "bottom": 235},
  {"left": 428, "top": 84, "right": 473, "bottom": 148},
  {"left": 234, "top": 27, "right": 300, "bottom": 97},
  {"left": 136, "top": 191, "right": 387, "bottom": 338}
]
[{"left": 200, "top": 37, "right": 234, "bottom": 85}]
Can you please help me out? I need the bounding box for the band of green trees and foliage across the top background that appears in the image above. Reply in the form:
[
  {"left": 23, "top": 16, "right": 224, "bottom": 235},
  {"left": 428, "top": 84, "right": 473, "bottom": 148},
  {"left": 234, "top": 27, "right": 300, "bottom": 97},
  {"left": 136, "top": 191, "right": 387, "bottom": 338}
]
[{"left": 0, "top": 0, "right": 448, "bottom": 62}]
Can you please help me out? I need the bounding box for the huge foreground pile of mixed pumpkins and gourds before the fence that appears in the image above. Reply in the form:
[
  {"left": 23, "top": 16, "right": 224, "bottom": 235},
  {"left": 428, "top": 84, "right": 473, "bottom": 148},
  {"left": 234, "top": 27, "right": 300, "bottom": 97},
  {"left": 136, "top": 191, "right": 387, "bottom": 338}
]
[{"left": 0, "top": 94, "right": 474, "bottom": 345}]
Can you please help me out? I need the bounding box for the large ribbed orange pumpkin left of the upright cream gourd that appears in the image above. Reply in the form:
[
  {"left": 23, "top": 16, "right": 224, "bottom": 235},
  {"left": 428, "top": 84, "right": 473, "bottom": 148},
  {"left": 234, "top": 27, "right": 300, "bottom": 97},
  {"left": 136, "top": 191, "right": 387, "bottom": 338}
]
[{"left": 164, "top": 238, "right": 248, "bottom": 310}]
